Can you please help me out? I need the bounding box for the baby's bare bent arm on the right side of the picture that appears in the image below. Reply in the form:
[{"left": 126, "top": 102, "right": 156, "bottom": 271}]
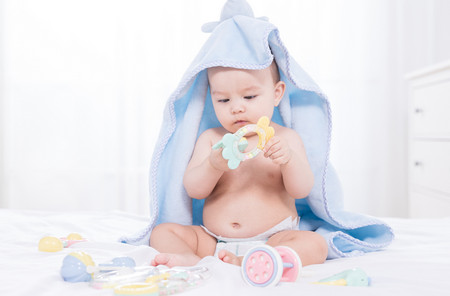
[{"left": 263, "top": 130, "right": 314, "bottom": 199}]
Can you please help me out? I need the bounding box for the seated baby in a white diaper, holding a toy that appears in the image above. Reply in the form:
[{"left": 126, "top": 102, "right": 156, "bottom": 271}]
[{"left": 150, "top": 62, "right": 328, "bottom": 267}]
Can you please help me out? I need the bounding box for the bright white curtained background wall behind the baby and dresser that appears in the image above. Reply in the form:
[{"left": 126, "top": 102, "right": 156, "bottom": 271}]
[{"left": 0, "top": 0, "right": 450, "bottom": 216}]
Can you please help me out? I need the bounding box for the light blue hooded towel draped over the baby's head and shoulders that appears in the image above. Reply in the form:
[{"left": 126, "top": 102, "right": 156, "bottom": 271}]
[{"left": 122, "top": 0, "right": 393, "bottom": 259}]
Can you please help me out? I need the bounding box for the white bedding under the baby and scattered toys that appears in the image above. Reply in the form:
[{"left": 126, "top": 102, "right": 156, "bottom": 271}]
[{"left": 0, "top": 209, "right": 450, "bottom": 296}]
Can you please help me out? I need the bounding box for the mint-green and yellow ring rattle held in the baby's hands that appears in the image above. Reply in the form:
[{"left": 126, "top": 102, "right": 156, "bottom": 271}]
[{"left": 212, "top": 116, "right": 275, "bottom": 170}]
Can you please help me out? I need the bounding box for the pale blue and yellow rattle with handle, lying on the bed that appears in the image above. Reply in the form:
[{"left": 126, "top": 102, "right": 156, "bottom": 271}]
[{"left": 60, "top": 252, "right": 136, "bottom": 283}]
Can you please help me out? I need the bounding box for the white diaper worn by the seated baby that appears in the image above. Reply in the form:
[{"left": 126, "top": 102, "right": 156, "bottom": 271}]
[{"left": 202, "top": 217, "right": 300, "bottom": 256}]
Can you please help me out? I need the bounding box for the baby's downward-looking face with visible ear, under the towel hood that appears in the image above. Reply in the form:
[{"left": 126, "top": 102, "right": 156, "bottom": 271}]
[{"left": 208, "top": 67, "right": 285, "bottom": 133}]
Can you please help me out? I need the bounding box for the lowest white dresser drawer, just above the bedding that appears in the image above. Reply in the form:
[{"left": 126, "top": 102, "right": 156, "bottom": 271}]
[{"left": 409, "top": 191, "right": 450, "bottom": 218}]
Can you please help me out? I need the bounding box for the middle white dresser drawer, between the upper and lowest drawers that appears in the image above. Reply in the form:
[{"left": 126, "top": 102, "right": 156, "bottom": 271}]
[{"left": 409, "top": 141, "right": 450, "bottom": 194}]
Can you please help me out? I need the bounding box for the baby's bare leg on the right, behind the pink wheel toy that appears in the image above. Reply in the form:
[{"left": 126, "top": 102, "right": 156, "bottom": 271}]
[{"left": 267, "top": 230, "right": 328, "bottom": 266}]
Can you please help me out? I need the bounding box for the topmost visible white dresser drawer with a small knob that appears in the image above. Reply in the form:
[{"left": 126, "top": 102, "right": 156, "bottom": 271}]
[{"left": 410, "top": 80, "right": 450, "bottom": 138}]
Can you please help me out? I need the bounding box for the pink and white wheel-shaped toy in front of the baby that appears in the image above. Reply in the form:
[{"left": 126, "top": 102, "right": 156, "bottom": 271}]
[{"left": 241, "top": 245, "right": 302, "bottom": 287}]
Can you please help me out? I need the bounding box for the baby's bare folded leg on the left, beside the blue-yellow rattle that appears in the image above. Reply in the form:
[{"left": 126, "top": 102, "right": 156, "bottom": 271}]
[{"left": 150, "top": 223, "right": 216, "bottom": 267}]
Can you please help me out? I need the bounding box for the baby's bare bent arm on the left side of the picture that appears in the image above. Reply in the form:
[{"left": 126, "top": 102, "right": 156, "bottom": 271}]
[{"left": 183, "top": 130, "right": 228, "bottom": 199}]
